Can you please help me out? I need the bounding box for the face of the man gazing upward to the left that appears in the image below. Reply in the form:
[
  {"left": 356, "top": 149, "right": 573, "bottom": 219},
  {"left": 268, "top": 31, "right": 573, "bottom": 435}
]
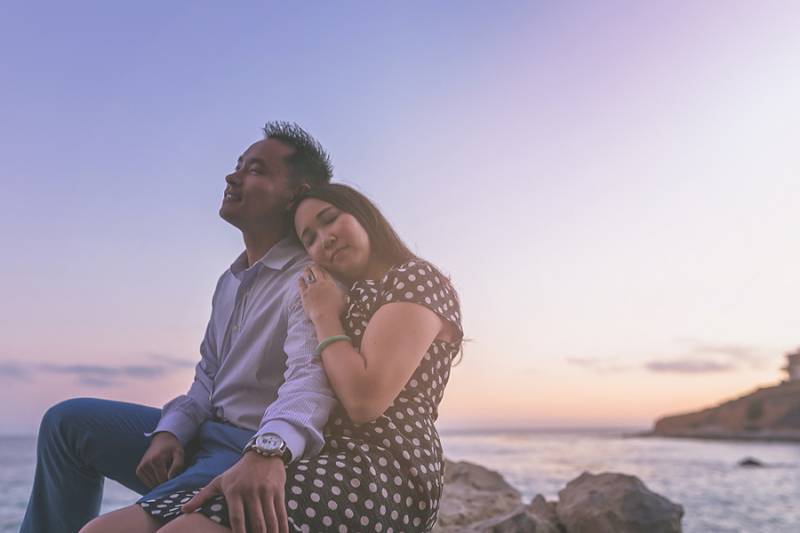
[{"left": 219, "top": 139, "right": 294, "bottom": 232}]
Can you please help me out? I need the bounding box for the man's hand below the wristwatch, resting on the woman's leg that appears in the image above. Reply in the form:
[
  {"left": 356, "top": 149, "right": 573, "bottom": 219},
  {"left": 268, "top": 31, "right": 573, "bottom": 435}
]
[{"left": 182, "top": 451, "right": 289, "bottom": 533}]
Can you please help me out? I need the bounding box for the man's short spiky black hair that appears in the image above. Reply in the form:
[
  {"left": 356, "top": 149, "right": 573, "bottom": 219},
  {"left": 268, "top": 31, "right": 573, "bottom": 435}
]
[{"left": 264, "top": 120, "right": 333, "bottom": 187}]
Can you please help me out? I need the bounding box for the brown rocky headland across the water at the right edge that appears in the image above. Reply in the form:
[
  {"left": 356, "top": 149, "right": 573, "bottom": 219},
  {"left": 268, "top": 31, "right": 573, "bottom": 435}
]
[{"left": 652, "top": 381, "right": 800, "bottom": 441}]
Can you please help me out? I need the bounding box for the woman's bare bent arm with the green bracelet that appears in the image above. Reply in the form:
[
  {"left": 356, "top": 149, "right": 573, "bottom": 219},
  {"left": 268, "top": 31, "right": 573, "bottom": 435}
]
[{"left": 314, "top": 302, "right": 445, "bottom": 424}]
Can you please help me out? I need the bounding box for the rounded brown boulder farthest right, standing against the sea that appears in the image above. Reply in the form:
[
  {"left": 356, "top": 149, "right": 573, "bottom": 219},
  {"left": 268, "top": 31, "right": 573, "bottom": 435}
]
[{"left": 556, "top": 472, "right": 683, "bottom": 533}]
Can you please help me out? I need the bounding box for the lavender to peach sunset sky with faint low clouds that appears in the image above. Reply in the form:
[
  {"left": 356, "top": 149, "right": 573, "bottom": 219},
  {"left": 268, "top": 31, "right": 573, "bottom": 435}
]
[{"left": 0, "top": 0, "right": 800, "bottom": 433}]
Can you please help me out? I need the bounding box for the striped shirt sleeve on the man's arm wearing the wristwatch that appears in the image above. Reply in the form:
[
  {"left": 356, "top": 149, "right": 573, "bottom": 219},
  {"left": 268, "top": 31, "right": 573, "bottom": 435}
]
[{"left": 256, "top": 286, "right": 336, "bottom": 460}]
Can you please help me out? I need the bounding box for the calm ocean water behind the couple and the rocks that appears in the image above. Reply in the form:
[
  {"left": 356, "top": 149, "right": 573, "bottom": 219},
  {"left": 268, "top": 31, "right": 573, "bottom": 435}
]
[{"left": 0, "top": 429, "right": 800, "bottom": 533}]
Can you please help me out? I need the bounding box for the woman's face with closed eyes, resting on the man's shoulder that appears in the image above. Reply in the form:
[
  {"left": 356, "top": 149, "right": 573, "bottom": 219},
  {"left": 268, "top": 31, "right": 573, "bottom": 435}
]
[{"left": 294, "top": 198, "right": 370, "bottom": 281}]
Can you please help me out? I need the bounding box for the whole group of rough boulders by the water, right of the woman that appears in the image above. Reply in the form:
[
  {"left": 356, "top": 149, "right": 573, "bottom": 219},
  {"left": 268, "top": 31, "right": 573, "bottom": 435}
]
[{"left": 434, "top": 461, "right": 683, "bottom": 533}]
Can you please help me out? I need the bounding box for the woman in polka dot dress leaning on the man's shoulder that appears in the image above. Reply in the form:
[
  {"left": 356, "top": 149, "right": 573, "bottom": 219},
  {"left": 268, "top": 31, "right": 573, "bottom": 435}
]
[{"left": 130, "top": 184, "right": 463, "bottom": 532}]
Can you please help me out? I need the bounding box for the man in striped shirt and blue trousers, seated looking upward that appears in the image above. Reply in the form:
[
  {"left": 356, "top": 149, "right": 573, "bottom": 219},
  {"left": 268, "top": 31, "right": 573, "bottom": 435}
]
[{"left": 21, "top": 122, "right": 335, "bottom": 533}]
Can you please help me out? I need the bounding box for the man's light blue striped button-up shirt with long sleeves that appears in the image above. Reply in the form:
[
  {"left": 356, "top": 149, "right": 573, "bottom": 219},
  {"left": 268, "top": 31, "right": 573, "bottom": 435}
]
[{"left": 155, "top": 237, "right": 336, "bottom": 460}]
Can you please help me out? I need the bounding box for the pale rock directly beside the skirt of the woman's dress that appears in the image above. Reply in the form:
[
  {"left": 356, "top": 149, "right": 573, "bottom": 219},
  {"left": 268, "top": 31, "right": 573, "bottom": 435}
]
[{"left": 433, "top": 460, "right": 522, "bottom": 533}]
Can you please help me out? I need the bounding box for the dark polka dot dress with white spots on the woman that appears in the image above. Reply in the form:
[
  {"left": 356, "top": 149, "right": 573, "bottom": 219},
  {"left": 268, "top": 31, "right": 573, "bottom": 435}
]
[{"left": 140, "top": 260, "right": 463, "bottom": 533}]
